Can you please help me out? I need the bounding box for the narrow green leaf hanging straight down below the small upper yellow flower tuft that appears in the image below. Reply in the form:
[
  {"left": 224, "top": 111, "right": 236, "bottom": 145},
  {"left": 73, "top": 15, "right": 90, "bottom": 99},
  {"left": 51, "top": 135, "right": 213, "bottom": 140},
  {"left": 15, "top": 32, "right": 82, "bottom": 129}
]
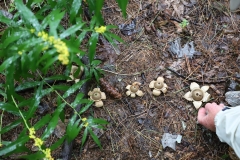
[{"left": 88, "top": 32, "right": 99, "bottom": 63}]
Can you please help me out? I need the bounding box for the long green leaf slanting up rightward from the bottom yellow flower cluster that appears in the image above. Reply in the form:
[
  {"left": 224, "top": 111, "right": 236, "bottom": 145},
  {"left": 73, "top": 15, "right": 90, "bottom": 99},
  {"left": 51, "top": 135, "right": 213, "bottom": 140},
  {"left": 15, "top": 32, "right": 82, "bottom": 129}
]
[{"left": 42, "top": 103, "right": 66, "bottom": 139}]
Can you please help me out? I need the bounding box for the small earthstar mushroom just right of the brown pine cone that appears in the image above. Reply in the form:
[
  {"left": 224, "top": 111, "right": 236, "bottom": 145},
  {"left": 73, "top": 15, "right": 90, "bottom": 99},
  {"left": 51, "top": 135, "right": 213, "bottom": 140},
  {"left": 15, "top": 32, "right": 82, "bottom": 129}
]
[{"left": 126, "top": 82, "right": 144, "bottom": 98}]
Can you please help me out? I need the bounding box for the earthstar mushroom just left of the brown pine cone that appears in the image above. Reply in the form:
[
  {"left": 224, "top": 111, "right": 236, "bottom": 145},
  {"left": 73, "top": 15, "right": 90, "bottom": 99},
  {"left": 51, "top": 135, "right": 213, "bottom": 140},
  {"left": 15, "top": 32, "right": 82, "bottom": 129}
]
[{"left": 88, "top": 88, "right": 106, "bottom": 107}]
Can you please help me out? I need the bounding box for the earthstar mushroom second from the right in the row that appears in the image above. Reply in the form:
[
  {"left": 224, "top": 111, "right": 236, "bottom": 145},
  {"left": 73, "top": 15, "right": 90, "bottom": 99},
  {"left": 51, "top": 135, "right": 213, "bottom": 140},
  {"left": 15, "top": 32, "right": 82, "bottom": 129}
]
[{"left": 149, "top": 77, "right": 168, "bottom": 96}]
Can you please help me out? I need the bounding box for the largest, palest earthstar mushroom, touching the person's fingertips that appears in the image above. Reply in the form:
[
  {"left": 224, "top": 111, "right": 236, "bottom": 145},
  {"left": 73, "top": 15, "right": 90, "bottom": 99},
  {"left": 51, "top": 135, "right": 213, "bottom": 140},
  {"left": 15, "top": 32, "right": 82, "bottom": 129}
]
[{"left": 183, "top": 82, "right": 211, "bottom": 109}]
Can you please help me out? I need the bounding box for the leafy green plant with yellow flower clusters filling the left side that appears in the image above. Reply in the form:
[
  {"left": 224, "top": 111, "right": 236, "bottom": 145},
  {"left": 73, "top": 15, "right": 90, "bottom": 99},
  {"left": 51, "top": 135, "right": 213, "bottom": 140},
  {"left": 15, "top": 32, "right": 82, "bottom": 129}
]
[{"left": 0, "top": 0, "right": 128, "bottom": 160}]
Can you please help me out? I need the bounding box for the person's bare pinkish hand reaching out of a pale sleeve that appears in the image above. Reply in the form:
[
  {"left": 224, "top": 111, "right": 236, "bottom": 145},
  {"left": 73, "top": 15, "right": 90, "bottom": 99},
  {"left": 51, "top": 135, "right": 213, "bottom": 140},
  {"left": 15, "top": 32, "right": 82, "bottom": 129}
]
[{"left": 198, "top": 103, "right": 224, "bottom": 132}]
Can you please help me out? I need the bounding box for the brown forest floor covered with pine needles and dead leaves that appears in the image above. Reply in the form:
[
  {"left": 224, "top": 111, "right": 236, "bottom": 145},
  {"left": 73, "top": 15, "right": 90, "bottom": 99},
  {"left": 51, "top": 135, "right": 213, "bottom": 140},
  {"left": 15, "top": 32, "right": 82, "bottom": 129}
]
[{"left": 0, "top": 0, "right": 240, "bottom": 160}]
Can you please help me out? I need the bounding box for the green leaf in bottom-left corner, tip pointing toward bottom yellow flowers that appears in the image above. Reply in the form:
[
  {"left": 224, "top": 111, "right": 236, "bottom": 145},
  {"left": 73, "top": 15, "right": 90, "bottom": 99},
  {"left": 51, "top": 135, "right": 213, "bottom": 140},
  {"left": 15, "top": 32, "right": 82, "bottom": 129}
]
[{"left": 0, "top": 135, "right": 29, "bottom": 156}]
